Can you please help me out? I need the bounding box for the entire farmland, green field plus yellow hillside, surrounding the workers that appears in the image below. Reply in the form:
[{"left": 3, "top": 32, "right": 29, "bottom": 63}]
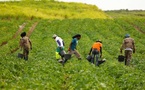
[{"left": 0, "top": 0, "right": 145, "bottom": 90}]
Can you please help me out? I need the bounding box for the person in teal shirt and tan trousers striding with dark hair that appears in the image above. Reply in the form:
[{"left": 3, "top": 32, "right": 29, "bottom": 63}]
[{"left": 68, "top": 34, "right": 81, "bottom": 60}]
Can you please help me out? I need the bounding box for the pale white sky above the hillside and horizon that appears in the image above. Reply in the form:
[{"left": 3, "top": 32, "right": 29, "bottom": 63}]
[{"left": 58, "top": 0, "right": 145, "bottom": 10}]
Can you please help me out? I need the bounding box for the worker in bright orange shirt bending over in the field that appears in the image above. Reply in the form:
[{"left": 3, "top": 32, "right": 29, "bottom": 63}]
[{"left": 89, "top": 40, "right": 102, "bottom": 66}]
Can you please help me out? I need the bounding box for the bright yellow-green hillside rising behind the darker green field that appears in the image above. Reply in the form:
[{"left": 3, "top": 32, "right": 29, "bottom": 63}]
[{"left": 0, "top": 0, "right": 108, "bottom": 19}]
